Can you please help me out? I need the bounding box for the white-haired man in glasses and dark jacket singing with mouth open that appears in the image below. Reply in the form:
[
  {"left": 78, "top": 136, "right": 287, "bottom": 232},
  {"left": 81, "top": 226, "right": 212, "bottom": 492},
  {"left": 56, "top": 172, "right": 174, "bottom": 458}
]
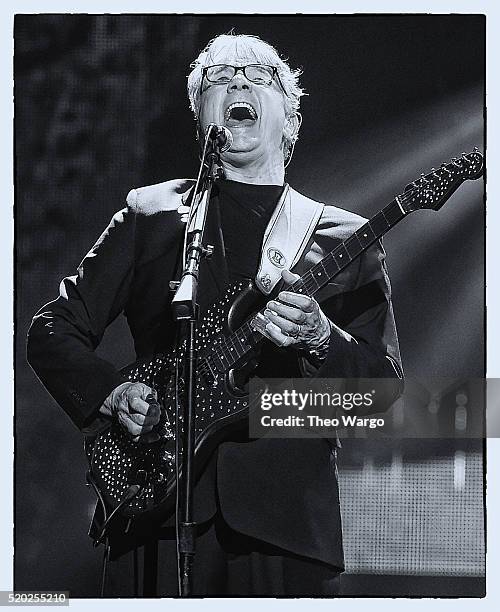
[{"left": 28, "top": 35, "right": 401, "bottom": 596}]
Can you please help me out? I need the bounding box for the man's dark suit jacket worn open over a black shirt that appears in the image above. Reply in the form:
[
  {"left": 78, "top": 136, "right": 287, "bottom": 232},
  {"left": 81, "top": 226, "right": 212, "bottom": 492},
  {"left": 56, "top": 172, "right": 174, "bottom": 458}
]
[{"left": 28, "top": 180, "right": 401, "bottom": 568}]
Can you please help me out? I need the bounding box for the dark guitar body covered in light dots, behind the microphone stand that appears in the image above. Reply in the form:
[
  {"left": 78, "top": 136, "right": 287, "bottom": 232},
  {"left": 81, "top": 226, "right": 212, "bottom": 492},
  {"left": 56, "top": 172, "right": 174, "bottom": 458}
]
[{"left": 85, "top": 281, "right": 266, "bottom": 520}]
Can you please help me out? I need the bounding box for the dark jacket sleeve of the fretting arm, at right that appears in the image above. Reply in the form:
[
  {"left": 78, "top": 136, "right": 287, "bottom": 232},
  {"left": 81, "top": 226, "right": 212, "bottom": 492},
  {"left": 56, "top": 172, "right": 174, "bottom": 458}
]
[{"left": 302, "top": 242, "right": 403, "bottom": 409}]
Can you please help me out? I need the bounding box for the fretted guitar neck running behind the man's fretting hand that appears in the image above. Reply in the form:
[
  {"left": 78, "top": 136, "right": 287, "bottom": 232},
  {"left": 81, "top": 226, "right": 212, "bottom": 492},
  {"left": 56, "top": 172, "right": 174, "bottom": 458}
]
[{"left": 205, "top": 198, "right": 406, "bottom": 372}]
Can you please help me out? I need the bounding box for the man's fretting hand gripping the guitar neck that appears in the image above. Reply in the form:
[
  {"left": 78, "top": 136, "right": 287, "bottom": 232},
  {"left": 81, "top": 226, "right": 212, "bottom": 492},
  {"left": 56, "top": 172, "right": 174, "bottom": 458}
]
[{"left": 264, "top": 270, "right": 330, "bottom": 349}]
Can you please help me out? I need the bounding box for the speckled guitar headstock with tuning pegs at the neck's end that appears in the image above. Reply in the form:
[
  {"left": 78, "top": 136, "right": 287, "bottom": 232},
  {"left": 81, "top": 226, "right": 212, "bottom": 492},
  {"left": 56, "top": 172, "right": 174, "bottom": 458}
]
[{"left": 397, "top": 148, "right": 483, "bottom": 213}]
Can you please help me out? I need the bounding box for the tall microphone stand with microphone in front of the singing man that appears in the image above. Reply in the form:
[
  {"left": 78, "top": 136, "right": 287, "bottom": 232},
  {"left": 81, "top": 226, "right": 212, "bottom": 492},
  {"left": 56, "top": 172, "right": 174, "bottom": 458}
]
[{"left": 172, "top": 124, "right": 230, "bottom": 597}]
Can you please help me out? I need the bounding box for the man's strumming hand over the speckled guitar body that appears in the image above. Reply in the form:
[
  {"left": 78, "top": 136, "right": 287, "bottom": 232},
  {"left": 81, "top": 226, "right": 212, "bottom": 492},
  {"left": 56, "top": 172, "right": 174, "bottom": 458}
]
[{"left": 99, "top": 382, "right": 160, "bottom": 442}]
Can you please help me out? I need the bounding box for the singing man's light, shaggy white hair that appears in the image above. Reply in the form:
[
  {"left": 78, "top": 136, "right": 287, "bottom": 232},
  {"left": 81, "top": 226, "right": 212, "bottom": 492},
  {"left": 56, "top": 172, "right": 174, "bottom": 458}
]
[{"left": 187, "top": 33, "right": 306, "bottom": 158}]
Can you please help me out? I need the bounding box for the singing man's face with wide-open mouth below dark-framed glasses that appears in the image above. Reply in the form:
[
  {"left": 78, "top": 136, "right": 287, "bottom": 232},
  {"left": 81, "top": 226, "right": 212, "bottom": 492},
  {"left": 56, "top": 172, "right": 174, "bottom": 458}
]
[{"left": 199, "top": 51, "right": 286, "bottom": 166}]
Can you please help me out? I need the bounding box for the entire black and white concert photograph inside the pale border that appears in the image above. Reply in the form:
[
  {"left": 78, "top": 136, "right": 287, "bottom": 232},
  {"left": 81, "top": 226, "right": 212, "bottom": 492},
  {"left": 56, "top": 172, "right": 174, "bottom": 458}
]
[{"left": 13, "top": 11, "right": 486, "bottom": 605}]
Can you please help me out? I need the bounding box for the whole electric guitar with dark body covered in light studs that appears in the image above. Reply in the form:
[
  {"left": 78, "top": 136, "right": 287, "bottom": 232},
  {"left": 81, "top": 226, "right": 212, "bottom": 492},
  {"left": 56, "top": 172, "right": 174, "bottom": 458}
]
[{"left": 85, "top": 149, "right": 483, "bottom": 523}]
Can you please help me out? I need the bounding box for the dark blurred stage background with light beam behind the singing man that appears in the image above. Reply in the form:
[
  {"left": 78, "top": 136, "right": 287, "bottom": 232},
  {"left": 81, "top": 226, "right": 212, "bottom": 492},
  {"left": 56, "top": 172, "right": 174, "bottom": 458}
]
[{"left": 15, "top": 15, "right": 485, "bottom": 597}]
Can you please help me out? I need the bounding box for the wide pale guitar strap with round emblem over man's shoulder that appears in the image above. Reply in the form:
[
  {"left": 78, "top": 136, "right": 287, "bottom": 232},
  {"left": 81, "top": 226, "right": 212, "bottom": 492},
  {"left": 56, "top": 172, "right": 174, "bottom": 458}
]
[{"left": 255, "top": 185, "right": 324, "bottom": 295}]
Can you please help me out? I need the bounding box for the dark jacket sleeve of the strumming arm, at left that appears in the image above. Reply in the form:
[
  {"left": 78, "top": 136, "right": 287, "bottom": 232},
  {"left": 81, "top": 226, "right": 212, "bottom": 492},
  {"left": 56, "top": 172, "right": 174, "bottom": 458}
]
[{"left": 27, "top": 207, "right": 136, "bottom": 429}]
